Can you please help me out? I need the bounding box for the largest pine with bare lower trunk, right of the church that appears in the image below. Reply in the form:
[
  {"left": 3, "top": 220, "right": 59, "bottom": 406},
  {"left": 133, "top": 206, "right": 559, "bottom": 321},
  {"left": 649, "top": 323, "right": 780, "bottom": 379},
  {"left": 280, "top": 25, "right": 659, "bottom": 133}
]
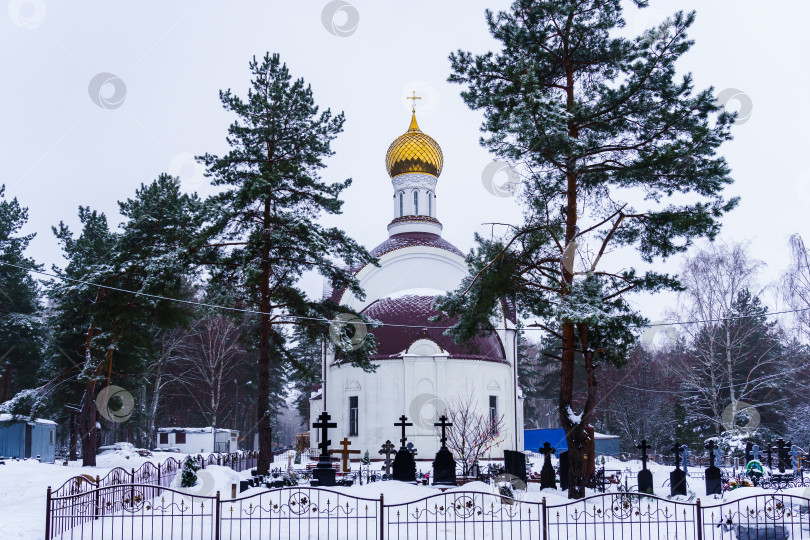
[{"left": 441, "top": 0, "right": 737, "bottom": 498}]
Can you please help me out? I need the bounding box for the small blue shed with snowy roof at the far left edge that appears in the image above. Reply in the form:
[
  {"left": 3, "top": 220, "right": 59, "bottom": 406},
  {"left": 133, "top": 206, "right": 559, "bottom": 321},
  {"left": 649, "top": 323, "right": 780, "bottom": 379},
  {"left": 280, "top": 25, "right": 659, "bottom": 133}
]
[{"left": 0, "top": 413, "right": 56, "bottom": 463}]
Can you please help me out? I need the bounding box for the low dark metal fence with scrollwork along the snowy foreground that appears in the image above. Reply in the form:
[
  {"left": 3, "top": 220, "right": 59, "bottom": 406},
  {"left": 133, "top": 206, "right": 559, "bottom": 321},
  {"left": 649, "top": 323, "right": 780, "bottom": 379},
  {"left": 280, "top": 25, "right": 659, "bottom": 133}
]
[{"left": 46, "top": 485, "right": 810, "bottom": 540}]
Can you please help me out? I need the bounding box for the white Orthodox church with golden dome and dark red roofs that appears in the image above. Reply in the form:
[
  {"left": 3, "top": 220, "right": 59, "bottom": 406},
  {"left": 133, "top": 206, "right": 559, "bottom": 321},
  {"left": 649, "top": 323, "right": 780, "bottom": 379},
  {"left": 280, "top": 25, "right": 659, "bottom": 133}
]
[{"left": 309, "top": 107, "right": 523, "bottom": 460}]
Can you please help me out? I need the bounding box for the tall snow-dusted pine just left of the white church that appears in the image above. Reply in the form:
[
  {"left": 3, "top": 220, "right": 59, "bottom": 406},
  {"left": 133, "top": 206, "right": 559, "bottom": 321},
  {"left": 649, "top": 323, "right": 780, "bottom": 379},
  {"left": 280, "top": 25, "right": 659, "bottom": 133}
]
[{"left": 200, "top": 54, "right": 378, "bottom": 474}]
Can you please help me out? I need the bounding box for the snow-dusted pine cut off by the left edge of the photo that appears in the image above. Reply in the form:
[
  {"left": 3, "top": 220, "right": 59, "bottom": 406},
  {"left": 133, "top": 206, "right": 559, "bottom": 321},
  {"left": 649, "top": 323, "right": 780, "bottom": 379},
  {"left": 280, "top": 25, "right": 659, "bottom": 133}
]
[{"left": 0, "top": 185, "right": 44, "bottom": 404}]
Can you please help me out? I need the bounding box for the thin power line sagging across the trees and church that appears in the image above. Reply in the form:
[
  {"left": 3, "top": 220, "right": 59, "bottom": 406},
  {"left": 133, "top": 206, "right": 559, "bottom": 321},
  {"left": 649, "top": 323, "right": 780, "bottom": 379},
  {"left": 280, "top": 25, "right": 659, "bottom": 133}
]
[{"left": 0, "top": 261, "right": 810, "bottom": 331}]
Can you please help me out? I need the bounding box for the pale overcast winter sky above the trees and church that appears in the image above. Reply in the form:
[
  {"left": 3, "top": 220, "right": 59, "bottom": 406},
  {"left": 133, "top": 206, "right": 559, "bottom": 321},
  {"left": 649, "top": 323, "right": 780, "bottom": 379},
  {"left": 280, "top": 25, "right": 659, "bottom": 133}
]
[{"left": 0, "top": 0, "right": 810, "bottom": 320}]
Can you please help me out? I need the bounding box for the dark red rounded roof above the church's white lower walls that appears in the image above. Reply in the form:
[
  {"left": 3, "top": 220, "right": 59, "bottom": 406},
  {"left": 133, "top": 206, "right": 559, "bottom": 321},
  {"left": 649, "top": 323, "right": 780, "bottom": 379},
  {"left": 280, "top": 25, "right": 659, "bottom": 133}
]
[{"left": 363, "top": 295, "right": 506, "bottom": 362}]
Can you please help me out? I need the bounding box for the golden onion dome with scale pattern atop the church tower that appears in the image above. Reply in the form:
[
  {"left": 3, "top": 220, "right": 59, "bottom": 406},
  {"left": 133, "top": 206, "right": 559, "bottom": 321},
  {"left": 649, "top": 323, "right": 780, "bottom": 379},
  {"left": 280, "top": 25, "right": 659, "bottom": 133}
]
[{"left": 385, "top": 113, "right": 444, "bottom": 178}]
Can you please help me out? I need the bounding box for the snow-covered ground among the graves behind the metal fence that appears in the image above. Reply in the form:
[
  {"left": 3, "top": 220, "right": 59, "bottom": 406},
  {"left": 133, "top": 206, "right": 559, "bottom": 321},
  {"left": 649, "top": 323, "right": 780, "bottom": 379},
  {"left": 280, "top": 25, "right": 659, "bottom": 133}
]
[{"left": 0, "top": 450, "right": 810, "bottom": 540}]
